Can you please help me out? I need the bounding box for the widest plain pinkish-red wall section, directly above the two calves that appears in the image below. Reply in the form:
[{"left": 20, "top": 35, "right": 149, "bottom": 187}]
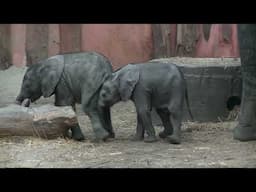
[{"left": 81, "top": 24, "right": 153, "bottom": 68}]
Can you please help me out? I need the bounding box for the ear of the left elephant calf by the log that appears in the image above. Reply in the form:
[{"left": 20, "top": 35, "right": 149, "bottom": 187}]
[{"left": 40, "top": 56, "right": 64, "bottom": 97}]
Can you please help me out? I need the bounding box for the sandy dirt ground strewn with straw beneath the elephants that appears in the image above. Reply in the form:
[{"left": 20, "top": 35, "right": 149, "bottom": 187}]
[{"left": 0, "top": 68, "right": 256, "bottom": 168}]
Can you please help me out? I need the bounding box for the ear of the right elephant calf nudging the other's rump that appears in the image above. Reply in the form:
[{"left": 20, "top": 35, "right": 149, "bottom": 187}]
[{"left": 119, "top": 67, "right": 140, "bottom": 101}]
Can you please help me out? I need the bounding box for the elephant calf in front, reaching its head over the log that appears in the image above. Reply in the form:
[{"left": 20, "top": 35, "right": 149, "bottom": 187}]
[{"left": 16, "top": 52, "right": 114, "bottom": 141}]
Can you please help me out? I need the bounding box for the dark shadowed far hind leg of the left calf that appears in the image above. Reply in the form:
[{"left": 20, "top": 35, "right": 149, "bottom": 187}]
[{"left": 99, "top": 107, "right": 115, "bottom": 138}]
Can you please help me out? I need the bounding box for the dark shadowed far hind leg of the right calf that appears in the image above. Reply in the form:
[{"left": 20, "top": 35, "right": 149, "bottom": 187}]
[{"left": 156, "top": 109, "right": 173, "bottom": 139}]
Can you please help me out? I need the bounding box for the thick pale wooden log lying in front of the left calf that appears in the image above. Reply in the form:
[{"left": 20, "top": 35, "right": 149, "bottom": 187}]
[{"left": 0, "top": 104, "right": 78, "bottom": 139}]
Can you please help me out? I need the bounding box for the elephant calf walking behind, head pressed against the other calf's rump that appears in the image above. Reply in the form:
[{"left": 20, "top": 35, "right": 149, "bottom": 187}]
[{"left": 99, "top": 63, "right": 191, "bottom": 144}]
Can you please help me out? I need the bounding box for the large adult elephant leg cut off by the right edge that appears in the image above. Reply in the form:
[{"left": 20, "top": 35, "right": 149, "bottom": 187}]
[{"left": 233, "top": 24, "right": 256, "bottom": 141}]
